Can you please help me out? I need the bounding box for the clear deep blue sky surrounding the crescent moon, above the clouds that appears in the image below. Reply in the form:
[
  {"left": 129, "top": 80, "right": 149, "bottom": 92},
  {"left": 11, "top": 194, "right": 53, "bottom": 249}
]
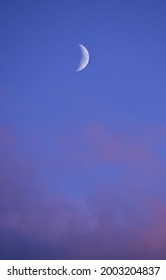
[{"left": 0, "top": 0, "right": 166, "bottom": 126}]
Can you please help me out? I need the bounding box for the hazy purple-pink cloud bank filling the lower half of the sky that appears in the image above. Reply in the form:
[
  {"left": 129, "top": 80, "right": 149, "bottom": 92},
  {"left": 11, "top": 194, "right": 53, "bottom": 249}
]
[{"left": 0, "top": 119, "right": 166, "bottom": 259}]
